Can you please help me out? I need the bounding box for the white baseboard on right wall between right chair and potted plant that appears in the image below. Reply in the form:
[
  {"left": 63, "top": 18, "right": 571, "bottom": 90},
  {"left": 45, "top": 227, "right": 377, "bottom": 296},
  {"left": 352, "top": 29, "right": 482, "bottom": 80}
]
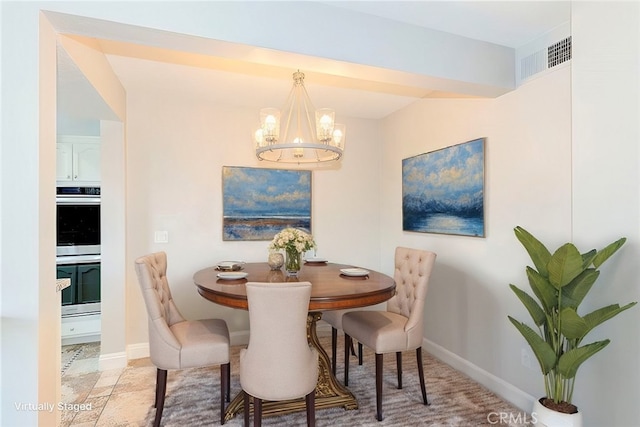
[{"left": 422, "top": 339, "right": 536, "bottom": 413}]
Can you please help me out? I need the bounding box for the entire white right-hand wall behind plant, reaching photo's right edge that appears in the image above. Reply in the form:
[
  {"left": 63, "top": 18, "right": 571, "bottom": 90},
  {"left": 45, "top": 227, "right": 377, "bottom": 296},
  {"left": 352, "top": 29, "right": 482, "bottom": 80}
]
[{"left": 381, "top": 2, "right": 640, "bottom": 426}]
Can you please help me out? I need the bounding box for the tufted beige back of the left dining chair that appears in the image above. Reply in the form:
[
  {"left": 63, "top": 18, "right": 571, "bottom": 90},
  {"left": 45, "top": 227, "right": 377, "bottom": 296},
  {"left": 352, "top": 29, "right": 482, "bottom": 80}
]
[{"left": 136, "top": 252, "right": 184, "bottom": 369}]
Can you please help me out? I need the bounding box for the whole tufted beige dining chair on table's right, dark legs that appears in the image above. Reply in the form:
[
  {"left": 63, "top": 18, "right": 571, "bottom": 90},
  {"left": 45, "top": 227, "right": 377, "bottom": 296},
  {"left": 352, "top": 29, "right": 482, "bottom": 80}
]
[{"left": 342, "top": 247, "right": 436, "bottom": 421}]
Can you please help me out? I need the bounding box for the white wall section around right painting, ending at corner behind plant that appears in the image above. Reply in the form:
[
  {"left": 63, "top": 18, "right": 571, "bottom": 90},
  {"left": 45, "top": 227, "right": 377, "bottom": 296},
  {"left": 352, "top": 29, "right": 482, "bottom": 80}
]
[{"left": 382, "top": 67, "right": 571, "bottom": 409}]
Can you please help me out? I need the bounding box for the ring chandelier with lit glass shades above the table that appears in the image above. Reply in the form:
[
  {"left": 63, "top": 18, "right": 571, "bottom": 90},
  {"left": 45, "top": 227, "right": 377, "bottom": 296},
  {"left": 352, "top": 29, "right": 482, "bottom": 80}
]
[{"left": 255, "top": 70, "right": 346, "bottom": 164}]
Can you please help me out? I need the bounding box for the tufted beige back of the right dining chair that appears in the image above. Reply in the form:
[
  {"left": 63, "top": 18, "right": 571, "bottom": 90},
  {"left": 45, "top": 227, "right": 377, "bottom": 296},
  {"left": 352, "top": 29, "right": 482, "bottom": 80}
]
[{"left": 387, "top": 247, "right": 436, "bottom": 352}]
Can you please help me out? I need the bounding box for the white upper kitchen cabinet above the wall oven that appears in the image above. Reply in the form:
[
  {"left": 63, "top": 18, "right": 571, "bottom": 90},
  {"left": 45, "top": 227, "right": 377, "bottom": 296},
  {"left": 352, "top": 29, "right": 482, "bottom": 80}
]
[{"left": 56, "top": 136, "right": 100, "bottom": 185}]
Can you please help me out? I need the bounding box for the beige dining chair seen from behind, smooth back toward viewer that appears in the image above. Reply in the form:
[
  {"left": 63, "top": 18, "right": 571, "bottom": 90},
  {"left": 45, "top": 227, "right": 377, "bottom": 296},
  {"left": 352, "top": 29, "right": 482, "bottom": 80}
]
[{"left": 240, "top": 282, "right": 318, "bottom": 427}]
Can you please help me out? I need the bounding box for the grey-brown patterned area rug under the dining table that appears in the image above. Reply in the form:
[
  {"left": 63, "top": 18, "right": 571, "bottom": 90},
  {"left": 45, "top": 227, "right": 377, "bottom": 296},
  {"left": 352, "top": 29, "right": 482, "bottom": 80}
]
[{"left": 145, "top": 337, "right": 530, "bottom": 427}]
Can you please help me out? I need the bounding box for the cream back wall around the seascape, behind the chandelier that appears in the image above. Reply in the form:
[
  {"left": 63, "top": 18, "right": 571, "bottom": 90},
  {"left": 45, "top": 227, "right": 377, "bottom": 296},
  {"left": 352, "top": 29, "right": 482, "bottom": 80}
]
[{"left": 126, "top": 88, "right": 380, "bottom": 344}]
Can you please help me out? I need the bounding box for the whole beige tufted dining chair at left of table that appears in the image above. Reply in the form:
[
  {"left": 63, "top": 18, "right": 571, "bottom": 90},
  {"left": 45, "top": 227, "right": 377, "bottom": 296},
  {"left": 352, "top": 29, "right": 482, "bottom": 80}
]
[{"left": 135, "top": 252, "right": 231, "bottom": 427}]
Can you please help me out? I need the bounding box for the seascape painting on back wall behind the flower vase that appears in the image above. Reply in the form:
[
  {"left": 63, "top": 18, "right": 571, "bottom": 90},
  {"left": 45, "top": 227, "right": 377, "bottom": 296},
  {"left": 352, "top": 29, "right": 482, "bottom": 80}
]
[{"left": 222, "top": 166, "right": 311, "bottom": 240}]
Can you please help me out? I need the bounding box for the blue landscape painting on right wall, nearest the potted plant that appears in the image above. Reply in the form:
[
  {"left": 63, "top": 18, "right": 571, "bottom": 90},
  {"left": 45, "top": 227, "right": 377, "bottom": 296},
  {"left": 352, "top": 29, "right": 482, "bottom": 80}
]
[{"left": 402, "top": 138, "right": 485, "bottom": 237}]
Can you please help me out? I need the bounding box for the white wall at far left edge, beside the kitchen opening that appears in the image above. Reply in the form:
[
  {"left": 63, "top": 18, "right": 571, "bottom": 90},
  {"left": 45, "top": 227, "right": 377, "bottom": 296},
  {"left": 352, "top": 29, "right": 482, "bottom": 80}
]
[{"left": 0, "top": 3, "right": 60, "bottom": 425}]
